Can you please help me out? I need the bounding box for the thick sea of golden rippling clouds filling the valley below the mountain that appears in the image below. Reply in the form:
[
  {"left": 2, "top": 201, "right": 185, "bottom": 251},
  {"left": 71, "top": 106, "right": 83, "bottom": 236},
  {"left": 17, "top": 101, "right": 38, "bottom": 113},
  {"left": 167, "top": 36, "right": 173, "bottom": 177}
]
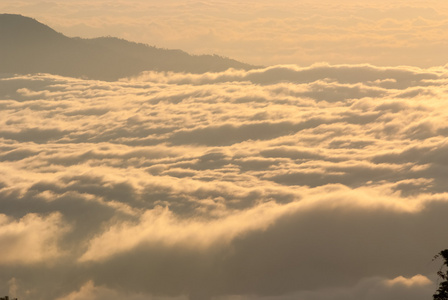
[{"left": 0, "top": 64, "right": 448, "bottom": 300}]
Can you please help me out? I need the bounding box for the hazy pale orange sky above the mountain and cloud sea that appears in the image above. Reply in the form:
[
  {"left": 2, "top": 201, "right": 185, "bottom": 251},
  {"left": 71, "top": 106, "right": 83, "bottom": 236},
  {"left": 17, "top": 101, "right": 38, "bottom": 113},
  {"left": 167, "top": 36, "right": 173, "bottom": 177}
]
[{"left": 0, "top": 0, "right": 448, "bottom": 67}]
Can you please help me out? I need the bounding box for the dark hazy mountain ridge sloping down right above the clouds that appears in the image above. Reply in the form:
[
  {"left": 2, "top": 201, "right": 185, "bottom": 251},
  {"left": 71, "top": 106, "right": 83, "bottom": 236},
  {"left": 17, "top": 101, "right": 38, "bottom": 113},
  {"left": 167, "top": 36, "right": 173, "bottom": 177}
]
[{"left": 0, "top": 14, "right": 255, "bottom": 80}]
